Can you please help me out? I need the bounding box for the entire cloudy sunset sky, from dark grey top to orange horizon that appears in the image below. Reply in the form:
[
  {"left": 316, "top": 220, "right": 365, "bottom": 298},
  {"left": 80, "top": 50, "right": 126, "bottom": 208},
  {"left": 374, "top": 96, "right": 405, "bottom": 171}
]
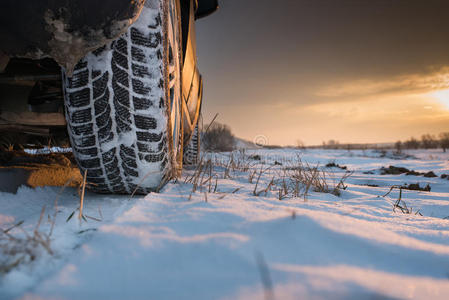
[{"left": 196, "top": 0, "right": 449, "bottom": 145}]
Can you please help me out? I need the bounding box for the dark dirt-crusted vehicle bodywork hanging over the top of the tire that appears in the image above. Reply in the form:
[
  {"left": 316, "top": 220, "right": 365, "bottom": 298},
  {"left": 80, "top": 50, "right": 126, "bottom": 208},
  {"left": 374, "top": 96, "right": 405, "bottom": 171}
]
[{"left": 0, "top": 0, "right": 145, "bottom": 73}]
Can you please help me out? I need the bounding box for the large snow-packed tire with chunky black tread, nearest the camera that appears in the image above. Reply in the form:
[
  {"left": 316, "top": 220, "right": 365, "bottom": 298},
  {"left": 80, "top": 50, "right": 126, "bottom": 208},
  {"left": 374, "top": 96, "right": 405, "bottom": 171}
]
[{"left": 64, "top": 0, "right": 180, "bottom": 194}]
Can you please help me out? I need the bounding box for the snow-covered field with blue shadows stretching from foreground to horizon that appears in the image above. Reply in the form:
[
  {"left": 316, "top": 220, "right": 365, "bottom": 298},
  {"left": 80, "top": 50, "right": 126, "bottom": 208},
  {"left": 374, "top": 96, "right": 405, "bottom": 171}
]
[{"left": 0, "top": 149, "right": 449, "bottom": 299}]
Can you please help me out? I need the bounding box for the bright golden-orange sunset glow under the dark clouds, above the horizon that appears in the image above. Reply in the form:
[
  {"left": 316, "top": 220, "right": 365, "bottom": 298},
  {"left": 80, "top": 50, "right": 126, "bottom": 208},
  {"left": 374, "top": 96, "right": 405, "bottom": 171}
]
[{"left": 201, "top": 68, "right": 449, "bottom": 145}]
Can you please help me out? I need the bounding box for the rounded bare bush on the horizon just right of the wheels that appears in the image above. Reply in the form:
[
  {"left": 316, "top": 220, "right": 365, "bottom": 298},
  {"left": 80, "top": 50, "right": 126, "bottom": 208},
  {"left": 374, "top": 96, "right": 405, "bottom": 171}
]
[{"left": 202, "top": 123, "right": 235, "bottom": 152}]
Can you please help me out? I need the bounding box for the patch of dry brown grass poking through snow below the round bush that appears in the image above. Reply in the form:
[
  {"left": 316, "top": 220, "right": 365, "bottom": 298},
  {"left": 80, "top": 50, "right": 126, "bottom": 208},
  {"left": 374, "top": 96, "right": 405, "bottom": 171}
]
[{"left": 184, "top": 151, "right": 352, "bottom": 200}]
